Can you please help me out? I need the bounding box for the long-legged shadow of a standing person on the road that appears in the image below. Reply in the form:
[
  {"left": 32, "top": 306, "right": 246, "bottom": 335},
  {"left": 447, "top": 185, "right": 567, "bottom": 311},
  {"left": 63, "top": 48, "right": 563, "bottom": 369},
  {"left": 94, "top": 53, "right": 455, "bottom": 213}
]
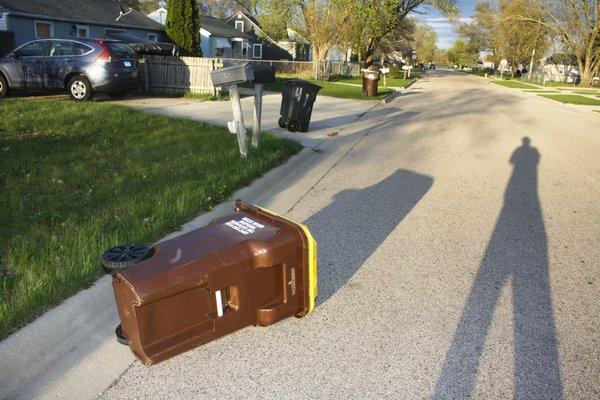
[{"left": 433, "top": 137, "right": 562, "bottom": 399}]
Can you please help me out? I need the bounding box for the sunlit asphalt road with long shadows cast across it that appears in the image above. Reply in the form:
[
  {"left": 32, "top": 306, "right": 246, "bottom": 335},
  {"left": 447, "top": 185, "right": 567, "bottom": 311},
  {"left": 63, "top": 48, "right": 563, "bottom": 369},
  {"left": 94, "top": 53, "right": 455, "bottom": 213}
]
[{"left": 102, "top": 71, "right": 600, "bottom": 399}]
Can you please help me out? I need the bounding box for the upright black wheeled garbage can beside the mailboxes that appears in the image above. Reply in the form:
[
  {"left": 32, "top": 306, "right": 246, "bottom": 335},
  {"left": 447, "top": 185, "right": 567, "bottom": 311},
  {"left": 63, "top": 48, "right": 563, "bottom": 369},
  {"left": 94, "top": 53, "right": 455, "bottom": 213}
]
[{"left": 279, "top": 79, "right": 321, "bottom": 132}]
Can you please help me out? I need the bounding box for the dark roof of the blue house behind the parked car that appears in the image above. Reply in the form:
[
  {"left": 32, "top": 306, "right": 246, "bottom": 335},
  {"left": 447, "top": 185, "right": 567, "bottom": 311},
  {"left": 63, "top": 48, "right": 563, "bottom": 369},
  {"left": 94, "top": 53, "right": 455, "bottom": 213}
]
[{"left": 0, "top": 0, "right": 164, "bottom": 31}]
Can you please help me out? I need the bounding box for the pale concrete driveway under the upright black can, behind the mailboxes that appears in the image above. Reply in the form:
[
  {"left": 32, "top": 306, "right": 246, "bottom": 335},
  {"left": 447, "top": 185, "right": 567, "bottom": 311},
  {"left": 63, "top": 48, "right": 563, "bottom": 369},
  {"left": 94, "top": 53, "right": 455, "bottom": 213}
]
[{"left": 115, "top": 92, "right": 379, "bottom": 147}]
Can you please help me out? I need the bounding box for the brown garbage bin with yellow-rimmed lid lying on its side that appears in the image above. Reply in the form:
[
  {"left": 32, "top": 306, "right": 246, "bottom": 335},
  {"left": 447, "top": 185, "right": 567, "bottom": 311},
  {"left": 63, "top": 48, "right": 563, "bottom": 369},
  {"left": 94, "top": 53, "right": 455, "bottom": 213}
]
[{"left": 108, "top": 201, "right": 317, "bottom": 365}]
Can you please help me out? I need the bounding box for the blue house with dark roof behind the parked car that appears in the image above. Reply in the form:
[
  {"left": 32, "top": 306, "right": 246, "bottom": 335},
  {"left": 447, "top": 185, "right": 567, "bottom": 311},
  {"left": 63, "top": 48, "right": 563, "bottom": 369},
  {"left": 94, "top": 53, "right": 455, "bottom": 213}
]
[{"left": 0, "top": 0, "right": 165, "bottom": 47}]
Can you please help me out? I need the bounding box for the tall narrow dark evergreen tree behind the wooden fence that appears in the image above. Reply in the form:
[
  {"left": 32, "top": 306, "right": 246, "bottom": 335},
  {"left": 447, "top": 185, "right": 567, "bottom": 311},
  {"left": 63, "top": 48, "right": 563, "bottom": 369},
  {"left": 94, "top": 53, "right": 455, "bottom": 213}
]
[{"left": 165, "top": 0, "right": 202, "bottom": 56}]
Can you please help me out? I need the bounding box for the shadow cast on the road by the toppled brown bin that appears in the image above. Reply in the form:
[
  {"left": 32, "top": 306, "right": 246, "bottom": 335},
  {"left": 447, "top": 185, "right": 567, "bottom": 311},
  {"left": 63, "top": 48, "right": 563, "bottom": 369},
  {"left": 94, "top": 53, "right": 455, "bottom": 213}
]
[{"left": 305, "top": 169, "right": 433, "bottom": 304}]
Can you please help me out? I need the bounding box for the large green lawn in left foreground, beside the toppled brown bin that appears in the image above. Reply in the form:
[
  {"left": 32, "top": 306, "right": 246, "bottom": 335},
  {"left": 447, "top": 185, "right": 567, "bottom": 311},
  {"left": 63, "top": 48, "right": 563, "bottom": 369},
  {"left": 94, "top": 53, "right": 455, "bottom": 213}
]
[{"left": 0, "top": 99, "right": 301, "bottom": 338}]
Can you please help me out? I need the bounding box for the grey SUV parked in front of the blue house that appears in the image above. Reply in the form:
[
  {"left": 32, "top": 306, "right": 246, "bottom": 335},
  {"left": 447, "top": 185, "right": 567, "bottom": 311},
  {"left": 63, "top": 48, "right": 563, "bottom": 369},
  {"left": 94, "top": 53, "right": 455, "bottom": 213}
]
[{"left": 0, "top": 39, "right": 142, "bottom": 101}]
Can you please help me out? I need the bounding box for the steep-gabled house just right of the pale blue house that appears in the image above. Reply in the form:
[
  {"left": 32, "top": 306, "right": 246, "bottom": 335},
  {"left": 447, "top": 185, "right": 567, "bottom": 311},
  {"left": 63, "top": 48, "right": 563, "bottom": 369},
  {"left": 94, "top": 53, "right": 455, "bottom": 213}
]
[{"left": 224, "top": 11, "right": 310, "bottom": 61}]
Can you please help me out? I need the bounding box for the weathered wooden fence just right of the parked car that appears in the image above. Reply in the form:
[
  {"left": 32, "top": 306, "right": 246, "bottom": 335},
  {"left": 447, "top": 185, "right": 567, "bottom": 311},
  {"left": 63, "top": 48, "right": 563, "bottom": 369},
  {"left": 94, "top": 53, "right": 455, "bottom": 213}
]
[{"left": 141, "top": 56, "right": 223, "bottom": 96}]
